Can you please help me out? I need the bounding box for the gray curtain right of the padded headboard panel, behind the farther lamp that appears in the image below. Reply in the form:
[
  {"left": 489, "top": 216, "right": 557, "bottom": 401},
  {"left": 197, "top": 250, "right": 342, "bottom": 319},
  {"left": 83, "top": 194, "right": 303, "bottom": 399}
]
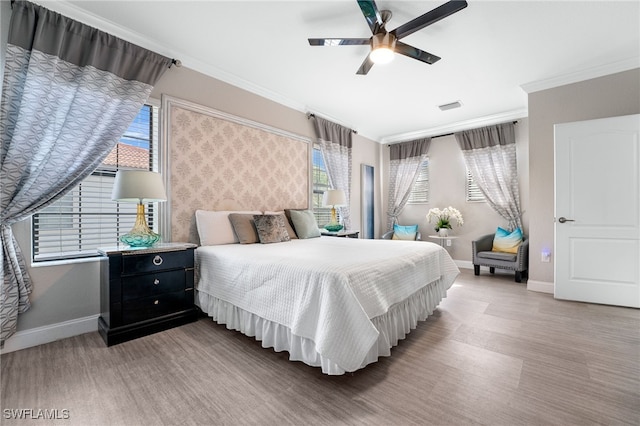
[{"left": 311, "top": 115, "right": 353, "bottom": 229}]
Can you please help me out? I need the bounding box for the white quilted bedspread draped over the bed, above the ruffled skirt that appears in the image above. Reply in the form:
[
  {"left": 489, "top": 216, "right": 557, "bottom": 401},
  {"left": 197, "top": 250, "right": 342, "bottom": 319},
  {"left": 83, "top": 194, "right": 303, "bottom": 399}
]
[{"left": 196, "top": 237, "right": 459, "bottom": 371}]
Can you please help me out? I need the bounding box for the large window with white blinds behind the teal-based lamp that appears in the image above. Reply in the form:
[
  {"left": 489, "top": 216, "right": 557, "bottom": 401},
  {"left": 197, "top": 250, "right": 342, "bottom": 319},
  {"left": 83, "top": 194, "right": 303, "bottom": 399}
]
[{"left": 31, "top": 105, "right": 158, "bottom": 262}]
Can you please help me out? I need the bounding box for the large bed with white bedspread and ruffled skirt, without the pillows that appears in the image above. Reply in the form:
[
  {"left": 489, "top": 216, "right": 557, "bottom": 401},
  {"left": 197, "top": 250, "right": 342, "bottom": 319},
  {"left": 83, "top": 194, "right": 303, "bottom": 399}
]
[{"left": 196, "top": 236, "right": 459, "bottom": 375}]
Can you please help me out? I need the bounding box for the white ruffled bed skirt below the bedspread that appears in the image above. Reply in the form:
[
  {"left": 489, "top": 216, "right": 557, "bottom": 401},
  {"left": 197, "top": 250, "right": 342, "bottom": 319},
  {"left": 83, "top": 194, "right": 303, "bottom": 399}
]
[{"left": 196, "top": 278, "right": 451, "bottom": 375}]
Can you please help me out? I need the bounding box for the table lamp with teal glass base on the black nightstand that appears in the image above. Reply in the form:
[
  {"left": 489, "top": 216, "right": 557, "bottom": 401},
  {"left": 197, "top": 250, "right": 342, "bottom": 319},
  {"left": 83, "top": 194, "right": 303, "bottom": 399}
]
[{"left": 111, "top": 170, "right": 167, "bottom": 247}]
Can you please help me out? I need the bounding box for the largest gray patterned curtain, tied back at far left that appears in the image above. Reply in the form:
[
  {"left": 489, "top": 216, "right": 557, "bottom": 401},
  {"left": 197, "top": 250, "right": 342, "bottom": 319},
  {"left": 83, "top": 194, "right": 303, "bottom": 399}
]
[{"left": 0, "top": 1, "right": 171, "bottom": 346}]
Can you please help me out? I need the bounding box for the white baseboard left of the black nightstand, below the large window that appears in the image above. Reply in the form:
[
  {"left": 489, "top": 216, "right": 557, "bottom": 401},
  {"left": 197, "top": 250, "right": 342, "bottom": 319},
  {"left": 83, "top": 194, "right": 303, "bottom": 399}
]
[{"left": 0, "top": 314, "right": 100, "bottom": 354}]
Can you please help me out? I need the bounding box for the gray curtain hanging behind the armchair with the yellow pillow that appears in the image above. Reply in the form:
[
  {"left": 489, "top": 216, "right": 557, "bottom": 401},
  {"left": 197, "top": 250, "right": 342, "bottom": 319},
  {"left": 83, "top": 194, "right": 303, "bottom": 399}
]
[{"left": 455, "top": 123, "right": 522, "bottom": 230}]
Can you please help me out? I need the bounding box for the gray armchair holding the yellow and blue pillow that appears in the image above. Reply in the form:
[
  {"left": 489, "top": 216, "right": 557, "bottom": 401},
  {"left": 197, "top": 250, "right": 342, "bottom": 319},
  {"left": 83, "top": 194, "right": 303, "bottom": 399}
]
[{"left": 471, "top": 234, "right": 529, "bottom": 283}]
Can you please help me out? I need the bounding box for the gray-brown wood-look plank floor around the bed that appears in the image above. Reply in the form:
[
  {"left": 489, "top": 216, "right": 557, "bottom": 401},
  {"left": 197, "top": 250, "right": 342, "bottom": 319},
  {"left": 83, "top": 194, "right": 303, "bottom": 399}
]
[{"left": 0, "top": 270, "right": 640, "bottom": 425}]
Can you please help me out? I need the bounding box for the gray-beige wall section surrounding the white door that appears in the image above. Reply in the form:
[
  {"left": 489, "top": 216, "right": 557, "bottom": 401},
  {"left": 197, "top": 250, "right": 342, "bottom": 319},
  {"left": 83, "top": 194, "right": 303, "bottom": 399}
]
[{"left": 529, "top": 69, "right": 640, "bottom": 289}]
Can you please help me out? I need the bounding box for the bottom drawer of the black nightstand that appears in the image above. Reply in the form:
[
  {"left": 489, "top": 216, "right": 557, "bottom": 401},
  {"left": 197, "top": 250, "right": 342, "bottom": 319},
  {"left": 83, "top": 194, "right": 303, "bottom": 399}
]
[{"left": 122, "top": 290, "right": 192, "bottom": 324}]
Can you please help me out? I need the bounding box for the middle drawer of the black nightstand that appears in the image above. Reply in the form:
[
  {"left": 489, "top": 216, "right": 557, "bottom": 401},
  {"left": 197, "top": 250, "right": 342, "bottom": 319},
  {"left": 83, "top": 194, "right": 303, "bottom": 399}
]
[{"left": 122, "top": 269, "right": 186, "bottom": 302}]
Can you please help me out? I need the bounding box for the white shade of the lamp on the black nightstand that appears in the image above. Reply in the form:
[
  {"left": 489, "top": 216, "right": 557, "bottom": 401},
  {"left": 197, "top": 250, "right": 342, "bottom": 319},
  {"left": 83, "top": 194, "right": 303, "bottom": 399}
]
[{"left": 111, "top": 170, "right": 167, "bottom": 203}]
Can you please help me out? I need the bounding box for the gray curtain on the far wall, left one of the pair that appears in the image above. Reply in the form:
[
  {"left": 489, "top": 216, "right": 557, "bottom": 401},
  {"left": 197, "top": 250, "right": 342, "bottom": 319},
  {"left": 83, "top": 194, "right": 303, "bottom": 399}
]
[{"left": 387, "top": 138, "right": 431, "bottom": 231}]
